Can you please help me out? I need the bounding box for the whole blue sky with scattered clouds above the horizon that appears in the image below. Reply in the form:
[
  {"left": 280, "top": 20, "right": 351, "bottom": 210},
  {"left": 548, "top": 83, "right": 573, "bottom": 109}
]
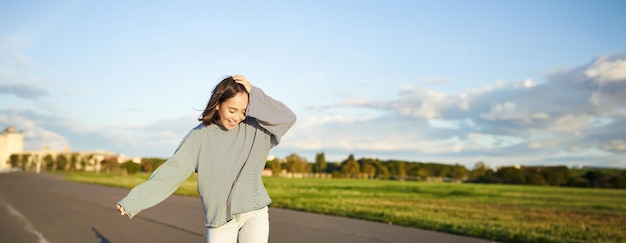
[{"left": 0, "top": 0, "right": 626, "bottom": 168}]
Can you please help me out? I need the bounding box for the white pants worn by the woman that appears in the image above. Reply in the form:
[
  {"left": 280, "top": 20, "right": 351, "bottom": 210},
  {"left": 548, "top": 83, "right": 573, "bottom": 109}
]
[{"left": 206, "top": 206, "right": 270, "bottom": 243}]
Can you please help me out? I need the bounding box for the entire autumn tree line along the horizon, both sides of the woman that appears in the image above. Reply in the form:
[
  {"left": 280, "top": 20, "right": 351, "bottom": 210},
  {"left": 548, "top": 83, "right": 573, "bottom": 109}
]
[{"left": 9, "top": 153, "right": 626, "bottom": 188}]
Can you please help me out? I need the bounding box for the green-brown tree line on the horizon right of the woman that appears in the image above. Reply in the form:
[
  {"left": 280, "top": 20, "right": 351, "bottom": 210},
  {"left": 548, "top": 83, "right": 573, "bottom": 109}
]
[{"left": 266, "top": 153, "right": 626, "bottom": 188}]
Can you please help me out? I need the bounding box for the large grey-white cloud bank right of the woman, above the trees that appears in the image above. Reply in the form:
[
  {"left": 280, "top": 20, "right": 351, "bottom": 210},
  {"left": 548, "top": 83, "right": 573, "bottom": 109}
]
[{"left": 289, "top": 50, "right": 626, "bottom": 167}]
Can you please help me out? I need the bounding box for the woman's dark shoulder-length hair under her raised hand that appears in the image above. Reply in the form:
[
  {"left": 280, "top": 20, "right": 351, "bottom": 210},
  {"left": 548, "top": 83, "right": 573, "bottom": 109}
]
[{"left": 198, "top": 76, "right": 248, "bottom": 126}]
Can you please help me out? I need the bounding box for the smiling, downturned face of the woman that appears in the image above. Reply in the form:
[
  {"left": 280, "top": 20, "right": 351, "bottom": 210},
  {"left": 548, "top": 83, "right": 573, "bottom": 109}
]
[{"left": 215, "top": 92, "right": 248, "bottom": 130}]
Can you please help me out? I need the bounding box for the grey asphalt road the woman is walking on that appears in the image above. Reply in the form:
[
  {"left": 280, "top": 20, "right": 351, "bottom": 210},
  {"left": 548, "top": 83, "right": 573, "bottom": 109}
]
[{"left": 0, "top": 173, "right": 490, "bottom": 243}]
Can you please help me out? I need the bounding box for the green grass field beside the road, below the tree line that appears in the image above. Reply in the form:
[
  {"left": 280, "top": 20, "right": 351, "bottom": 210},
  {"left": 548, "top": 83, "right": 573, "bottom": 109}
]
[{"left": 67, "top": 173, "right": 626, "bottom": 242}]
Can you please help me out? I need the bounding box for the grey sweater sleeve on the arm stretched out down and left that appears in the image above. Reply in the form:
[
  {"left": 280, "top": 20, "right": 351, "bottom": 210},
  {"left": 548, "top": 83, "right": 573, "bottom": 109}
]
[{"left": 118, "top": 130, "right": 199, "bottom": 219}]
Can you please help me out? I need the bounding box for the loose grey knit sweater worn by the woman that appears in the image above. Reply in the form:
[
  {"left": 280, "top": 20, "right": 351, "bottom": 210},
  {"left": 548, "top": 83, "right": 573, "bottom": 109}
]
[{"left": 119, "top": 87, "right": 296, "bottom": 227}]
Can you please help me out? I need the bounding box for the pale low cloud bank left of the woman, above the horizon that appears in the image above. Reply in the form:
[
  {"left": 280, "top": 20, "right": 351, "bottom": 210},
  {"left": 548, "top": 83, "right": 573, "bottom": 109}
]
[{"left": 0, "top": 107, "right": 198, "bottom": 157}]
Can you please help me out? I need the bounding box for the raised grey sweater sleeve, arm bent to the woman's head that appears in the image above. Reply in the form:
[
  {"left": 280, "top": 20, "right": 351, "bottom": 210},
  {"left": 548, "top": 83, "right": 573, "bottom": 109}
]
[{"left": 246, "top": 86, "right": 296, "bottom": 146}]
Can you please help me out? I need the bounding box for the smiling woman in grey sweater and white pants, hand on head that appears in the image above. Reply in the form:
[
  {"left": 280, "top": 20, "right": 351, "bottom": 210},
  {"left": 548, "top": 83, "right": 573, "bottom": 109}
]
[{"left": 117, "top": 75, "right": 296, "bottom": 242}]
